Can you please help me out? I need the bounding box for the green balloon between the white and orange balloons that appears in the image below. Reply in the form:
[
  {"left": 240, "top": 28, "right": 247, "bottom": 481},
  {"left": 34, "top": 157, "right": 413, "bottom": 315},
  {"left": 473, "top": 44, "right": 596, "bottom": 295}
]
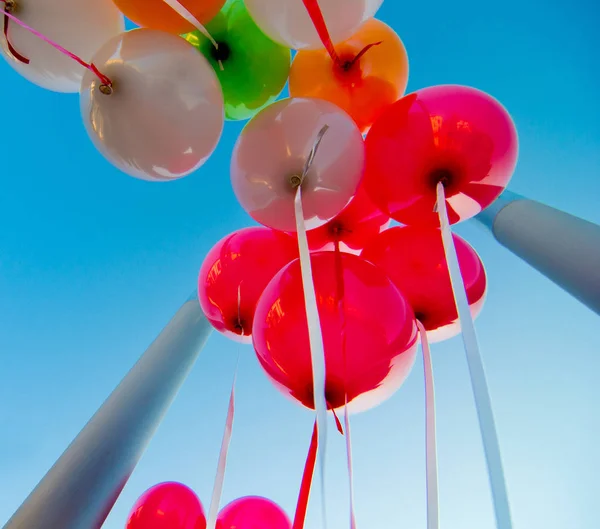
[{"left": 183, "top": 0, "right": 291, "bottom": 120}]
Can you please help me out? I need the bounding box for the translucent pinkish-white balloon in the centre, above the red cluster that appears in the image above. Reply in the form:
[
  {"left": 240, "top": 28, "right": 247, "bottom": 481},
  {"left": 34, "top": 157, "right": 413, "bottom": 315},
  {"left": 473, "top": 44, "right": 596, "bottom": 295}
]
[{"left": 231, "top": 98, "right": 364, "bottom": 232}]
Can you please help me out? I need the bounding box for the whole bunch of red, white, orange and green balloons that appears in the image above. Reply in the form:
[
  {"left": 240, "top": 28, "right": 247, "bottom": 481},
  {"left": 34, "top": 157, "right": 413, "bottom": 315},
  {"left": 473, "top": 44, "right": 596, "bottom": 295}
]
[{"left": 0, "top": 0, "right": 518, "bottom": 529}]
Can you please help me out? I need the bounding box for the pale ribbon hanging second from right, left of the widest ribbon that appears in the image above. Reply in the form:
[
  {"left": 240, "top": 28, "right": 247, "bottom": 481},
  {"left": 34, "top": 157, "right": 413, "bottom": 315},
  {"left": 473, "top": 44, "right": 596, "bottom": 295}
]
[{"left": 417, "top": 320, "right": 439, "bottom": 529}]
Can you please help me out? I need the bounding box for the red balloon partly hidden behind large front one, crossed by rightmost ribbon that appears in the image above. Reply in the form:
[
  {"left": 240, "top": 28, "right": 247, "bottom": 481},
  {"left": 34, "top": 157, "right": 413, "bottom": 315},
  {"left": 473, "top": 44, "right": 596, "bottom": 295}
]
[{"left": 361, "top": 226, "right": 487, "bottom": 342}]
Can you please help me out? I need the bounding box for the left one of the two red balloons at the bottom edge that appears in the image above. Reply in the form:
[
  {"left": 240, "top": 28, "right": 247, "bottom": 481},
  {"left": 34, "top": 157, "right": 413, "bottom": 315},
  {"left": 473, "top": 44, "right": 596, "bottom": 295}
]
[{"left": 127, "top": 482, "right": 206, "bottom": 529}]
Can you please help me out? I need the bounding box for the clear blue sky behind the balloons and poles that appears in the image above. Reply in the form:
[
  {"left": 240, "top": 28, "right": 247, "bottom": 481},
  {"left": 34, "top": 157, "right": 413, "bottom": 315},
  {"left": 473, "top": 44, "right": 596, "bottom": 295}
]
[{"left": 0, "top": 0, "right": 600, "bottom": 529}]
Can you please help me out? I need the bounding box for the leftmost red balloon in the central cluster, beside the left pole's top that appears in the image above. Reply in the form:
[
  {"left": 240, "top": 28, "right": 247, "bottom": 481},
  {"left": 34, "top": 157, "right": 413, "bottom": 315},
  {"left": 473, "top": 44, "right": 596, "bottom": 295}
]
[{"left": 198, "top": 228, "right": 298, "bottom": 343}]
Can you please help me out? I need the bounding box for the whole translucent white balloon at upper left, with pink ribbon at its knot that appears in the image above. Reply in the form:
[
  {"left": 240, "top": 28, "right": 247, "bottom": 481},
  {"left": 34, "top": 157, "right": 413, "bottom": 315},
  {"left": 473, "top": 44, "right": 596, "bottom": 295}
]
[{"left": 80, "top": 29, "right": 224, "bottom": 181}]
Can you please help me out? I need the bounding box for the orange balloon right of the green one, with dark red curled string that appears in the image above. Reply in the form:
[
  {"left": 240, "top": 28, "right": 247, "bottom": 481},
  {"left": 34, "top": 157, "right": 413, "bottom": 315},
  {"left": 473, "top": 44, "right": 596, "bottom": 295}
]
[{"left": 290, "top": 19, "right": 408, "bottom": 133}]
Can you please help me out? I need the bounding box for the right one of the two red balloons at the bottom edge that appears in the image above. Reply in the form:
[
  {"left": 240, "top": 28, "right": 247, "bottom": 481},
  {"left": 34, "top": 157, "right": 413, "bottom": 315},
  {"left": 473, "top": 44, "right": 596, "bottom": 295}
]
[{"left": 216, "top": 496, "right": 292, "bottom": 529}]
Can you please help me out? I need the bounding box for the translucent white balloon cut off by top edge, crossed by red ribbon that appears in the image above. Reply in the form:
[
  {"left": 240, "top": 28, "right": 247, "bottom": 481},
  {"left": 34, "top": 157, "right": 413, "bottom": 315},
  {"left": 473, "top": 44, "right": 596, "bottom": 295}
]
[{"left": 245, "top": 0, "right": 383, "bottom": 50}]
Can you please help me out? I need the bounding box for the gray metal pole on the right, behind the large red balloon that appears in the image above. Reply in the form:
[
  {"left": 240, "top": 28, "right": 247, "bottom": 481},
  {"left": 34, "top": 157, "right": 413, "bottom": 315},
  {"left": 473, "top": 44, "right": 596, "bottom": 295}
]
[{"left": 475, "top": 191, "right": 600, "bottom": 314}]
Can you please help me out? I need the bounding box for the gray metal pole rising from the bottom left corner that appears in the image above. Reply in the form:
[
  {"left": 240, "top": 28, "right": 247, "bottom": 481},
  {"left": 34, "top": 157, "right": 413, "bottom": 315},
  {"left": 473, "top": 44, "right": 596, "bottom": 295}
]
[{"left": 4, "top": 294, "right": 211, "bottom": 529}]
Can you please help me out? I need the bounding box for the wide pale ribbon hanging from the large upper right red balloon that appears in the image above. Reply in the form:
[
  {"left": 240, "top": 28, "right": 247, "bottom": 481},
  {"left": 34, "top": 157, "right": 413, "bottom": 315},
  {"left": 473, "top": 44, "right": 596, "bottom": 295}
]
[{"left": 437, "top": 182, "right": 512, "bottom": 529}]
